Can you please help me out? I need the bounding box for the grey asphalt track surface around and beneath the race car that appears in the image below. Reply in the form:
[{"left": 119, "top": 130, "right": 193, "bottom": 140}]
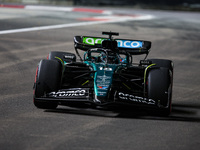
[{"left": 0, "top": 5, "right": 200, "bottom": 150}]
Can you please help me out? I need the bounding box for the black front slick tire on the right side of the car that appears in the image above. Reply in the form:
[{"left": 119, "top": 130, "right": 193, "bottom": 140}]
[{"left": 148, "top": 67, "right": 172, "bottom": 116}]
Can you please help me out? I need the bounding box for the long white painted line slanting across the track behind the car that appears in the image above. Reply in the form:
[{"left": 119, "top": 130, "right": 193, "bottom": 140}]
[{"left": 0, "top": 15, "right": 154, "bottom": 35}]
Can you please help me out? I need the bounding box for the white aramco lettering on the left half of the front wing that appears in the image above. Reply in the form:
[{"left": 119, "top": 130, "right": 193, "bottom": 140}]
[{"left": 48, "top": 90, "right": 86, "bottom": 97}]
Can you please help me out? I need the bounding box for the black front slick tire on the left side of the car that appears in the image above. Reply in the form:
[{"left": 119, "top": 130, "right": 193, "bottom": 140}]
[{"left": 34, "top": 60, "right": 62, "bottom": 109}]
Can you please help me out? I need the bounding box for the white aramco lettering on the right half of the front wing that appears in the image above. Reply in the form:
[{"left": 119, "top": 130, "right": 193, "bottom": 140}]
[{"left": 118, "top": 92, "right": 156, "bottom": 105}]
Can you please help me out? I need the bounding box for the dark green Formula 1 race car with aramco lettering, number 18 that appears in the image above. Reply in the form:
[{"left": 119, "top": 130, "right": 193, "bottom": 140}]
[{"left": 33, "top": 32, "right": 173, "bottom": 115}]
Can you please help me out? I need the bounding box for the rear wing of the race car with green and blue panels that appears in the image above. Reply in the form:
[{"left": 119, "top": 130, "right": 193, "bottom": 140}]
[{"left": 74, "top": 36, "right": 151, "bottom": 55}]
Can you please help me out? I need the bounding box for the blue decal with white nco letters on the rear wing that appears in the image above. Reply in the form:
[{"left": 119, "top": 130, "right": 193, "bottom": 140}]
[{"left": 116, "top": 40, "right": 143, "bottom": 48}]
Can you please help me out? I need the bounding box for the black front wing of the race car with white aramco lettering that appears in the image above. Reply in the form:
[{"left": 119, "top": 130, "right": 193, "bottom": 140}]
[{"left": 35, "top": 88, "right": 167, "bottom": 108}]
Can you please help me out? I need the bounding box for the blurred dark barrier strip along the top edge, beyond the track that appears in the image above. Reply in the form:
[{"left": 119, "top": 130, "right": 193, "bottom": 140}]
[{"left": 0, "top": 0, "right": 200, "bottom": 11}]
